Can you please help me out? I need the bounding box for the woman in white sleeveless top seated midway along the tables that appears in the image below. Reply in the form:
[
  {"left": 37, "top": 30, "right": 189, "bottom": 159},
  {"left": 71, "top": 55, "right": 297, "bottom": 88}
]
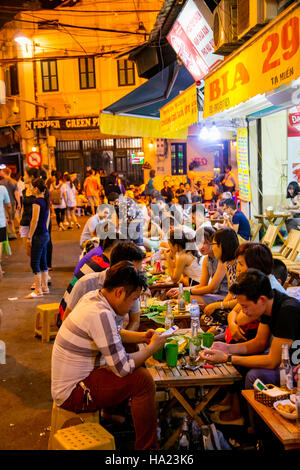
[{"left": 166, "top": 227, "right": 201, "bottom": 286}]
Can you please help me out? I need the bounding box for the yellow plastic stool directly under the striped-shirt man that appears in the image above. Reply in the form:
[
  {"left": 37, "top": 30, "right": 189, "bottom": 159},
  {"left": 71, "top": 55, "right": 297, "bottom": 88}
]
[{"left": 48, "top": 402, "right": 99, "bottom": 450}]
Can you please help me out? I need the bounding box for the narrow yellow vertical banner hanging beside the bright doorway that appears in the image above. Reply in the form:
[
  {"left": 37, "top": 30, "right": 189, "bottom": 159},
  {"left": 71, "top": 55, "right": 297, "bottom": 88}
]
[{"left": 237, "top": 127, "right": 251, "bottom": 202}]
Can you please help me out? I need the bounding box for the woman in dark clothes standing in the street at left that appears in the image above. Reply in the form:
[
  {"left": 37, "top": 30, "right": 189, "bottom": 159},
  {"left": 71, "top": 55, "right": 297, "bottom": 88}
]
[{"left": 25, "top": 178, "right": 50, "bottom": 299}]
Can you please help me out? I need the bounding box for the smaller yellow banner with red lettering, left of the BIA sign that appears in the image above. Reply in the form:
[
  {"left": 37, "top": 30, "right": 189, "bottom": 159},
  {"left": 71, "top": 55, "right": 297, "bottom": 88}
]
[{"left": 160, "top": 84, "right": 198, "bottom": 135}]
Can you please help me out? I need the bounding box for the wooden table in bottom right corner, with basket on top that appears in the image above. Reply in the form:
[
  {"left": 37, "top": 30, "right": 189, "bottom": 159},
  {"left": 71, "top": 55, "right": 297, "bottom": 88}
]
[{"left": 242, "top": 390, "right": 300, "bottom": 450}]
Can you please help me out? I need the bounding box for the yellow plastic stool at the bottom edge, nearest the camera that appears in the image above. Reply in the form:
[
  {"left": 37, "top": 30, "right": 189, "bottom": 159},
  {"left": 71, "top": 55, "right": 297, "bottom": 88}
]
[{"left": 53, "top": 423, "right": 116, "bottom": 450}]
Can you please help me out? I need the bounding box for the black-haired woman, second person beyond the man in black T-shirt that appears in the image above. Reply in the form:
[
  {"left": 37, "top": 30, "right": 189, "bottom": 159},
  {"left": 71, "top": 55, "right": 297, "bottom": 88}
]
[{"left": 204, "top": 228, "right": 239, "bottom": 316}]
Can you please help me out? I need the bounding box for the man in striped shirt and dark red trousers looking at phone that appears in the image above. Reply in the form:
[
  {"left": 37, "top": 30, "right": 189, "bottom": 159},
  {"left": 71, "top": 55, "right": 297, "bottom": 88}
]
[{"left": 51, "top": 261, "right": 167, "bottom": 450}]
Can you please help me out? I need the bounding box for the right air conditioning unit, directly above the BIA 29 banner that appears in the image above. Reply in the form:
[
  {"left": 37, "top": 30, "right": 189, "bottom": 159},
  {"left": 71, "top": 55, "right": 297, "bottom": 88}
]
[{"left": 237, "top": 0, "right": 278, "bottom": 40}]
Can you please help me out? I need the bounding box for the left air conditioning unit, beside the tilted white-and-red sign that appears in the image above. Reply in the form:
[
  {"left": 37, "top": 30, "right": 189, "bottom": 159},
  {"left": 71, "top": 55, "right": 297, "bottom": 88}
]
[{"left": 213, "top": 0, "right": 238, "bottom": 55}]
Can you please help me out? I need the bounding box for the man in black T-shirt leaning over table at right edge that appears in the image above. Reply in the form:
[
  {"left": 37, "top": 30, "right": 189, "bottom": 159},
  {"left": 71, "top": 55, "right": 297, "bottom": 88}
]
[{"left": 200, "top": 268, "right": 300, "bottom": 424}]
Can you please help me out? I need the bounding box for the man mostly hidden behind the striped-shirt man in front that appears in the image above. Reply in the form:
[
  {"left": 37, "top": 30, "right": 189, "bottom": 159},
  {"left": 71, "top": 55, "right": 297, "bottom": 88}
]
[{"left": 62, "top": 242, "right": 146, "bottom": 331}]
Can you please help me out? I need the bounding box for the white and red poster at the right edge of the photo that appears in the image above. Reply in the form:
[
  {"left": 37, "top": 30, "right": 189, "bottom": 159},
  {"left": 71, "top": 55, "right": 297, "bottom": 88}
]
[{"left": 288, "top": 106, "right": 300, "bottom": 184}]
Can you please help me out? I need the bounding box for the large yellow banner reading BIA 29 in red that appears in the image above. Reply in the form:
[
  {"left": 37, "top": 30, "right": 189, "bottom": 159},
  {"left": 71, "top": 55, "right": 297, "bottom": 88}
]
[{"left": 203, "top": 1, "right": 300, "bottom": 118}]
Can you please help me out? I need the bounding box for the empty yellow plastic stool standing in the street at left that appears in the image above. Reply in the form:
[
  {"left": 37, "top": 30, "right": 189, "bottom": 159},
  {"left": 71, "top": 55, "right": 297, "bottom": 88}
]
[{"left": 34, "top": 303, "right": 59, "bottom": 343}]
